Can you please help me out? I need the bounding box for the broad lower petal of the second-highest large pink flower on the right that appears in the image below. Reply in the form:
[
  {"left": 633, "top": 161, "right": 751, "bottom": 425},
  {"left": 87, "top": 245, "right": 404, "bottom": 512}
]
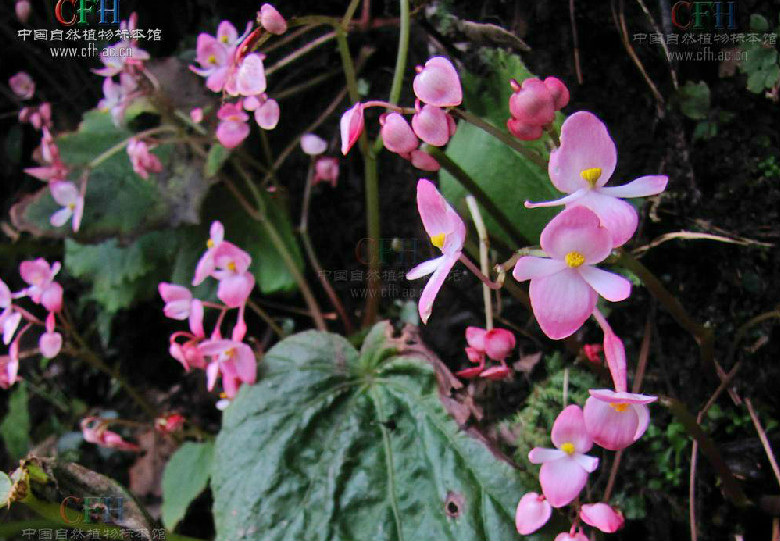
[{"left": 529, "top": 269, "right": 597, "bottom": 340}]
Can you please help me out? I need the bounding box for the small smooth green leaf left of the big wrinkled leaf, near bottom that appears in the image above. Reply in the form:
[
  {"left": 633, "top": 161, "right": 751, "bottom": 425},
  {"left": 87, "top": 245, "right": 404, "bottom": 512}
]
[{"left": 162, "top": 442, "right": 214, "bottom": 530}]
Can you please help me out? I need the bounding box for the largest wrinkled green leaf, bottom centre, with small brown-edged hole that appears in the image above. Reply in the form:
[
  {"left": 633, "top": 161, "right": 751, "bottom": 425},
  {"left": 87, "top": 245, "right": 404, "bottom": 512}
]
[{"left": 211, "top": 322, "right": 526, "bottom": 541}]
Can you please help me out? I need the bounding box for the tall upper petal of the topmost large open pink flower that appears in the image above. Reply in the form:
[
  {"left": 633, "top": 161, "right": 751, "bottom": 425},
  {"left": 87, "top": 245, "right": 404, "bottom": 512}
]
[{"left": 548, "top": 111, "right": 617, "bottom": 193}]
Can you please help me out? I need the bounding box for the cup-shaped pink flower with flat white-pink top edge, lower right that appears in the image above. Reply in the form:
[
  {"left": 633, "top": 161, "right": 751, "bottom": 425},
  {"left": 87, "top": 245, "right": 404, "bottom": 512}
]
[{"left": 585, "top": 389, "right": 658, "bottom": 451}]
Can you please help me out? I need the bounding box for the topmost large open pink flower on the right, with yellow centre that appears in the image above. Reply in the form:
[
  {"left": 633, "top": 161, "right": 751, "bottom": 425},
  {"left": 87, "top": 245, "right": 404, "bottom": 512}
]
[{"left": 526, "top": 111, "right": 669, "bottom": 246}]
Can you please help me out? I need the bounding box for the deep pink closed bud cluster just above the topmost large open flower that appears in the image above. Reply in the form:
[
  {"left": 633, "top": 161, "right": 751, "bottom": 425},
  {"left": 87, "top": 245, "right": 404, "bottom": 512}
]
[{"left": 506, "top": 77, "right": 569, "bottom": 141}]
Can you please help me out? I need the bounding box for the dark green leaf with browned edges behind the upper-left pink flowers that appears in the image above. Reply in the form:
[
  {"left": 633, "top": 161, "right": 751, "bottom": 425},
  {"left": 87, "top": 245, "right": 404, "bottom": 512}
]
[{"left": 11, "top": 110, "right": 210, "bottom": 242}]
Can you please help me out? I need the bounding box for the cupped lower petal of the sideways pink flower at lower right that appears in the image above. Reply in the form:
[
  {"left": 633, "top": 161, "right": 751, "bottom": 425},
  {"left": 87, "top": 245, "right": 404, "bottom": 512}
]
[{"left": 585, "top": 396, "right": 639, "bottom": 451}]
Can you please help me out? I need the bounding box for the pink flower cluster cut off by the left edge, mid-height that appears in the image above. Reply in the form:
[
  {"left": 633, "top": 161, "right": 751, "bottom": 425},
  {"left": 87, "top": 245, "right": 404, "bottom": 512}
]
[{"left": 0, "top": 258, "right": 63, "bottom": 389}]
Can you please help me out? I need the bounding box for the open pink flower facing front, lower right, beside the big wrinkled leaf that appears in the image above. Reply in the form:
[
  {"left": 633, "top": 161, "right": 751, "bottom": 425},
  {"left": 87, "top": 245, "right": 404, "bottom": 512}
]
[{"left": 528, "top": 404, "right": 599, "bottom": 507}]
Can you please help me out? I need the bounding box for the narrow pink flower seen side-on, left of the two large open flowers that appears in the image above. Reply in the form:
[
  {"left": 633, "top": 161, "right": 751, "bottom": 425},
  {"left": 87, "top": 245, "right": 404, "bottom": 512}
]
[{"left": 406, "top": 178, "right": 466, "bottom": 323}]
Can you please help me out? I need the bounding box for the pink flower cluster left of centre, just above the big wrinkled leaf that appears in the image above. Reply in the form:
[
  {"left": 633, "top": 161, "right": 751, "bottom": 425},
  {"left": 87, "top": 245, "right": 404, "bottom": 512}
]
[{"left": 159, "top": 222, "right": 257, "bottom": 399}]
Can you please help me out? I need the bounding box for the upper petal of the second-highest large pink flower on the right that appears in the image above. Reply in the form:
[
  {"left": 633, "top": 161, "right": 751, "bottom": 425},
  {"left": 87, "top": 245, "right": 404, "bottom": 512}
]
[{"left": 539, "top": 205, "right": 619, "bottom": 265}]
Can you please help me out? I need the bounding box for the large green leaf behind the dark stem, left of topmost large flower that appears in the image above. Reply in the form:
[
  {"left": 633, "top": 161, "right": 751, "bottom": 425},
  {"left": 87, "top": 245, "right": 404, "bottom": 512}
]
[{"left": 441, "top": 51, "right": 562, "bottom": 246}]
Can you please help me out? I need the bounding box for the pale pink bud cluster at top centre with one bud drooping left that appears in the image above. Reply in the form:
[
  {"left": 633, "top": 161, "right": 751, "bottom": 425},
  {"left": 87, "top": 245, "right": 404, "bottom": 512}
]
[{"left": 341, "top": 56, "right": 463, "bottom": 171}]
